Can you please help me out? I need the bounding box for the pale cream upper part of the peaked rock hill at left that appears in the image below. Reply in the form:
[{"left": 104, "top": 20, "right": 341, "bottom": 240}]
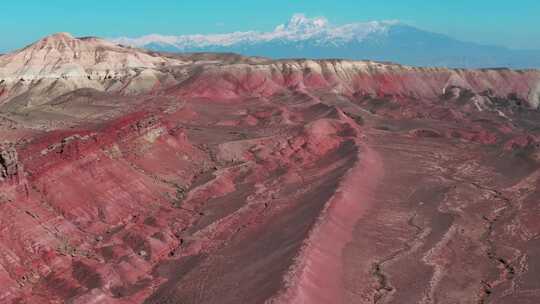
[{"left": 0, "top": 33, "right": 183, "bottom": 82}]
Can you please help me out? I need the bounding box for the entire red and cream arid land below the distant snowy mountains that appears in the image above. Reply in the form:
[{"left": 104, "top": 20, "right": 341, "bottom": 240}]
[{"left": 0, "top": 33, "right": 540, "bottom": 304}]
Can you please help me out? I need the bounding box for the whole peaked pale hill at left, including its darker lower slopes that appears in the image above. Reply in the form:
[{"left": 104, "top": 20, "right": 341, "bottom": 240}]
[{"left": 0, "top": 33, "right": 186, "bottom": 111}]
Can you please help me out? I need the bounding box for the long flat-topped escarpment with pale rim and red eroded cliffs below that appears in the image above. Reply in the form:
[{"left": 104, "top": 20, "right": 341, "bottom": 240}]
[{"left": 170, "top": 60, "right": 540, "bottom": 108}]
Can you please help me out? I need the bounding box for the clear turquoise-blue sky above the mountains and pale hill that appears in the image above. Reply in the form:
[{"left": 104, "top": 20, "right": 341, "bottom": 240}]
[{"left": 0, "top": 0, "right": 540, "bottom": 52}]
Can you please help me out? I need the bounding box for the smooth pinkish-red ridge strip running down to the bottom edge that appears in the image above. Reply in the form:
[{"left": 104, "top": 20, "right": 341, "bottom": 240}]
[{"left": 270, "top": 142, "right": 383, "bottom": 303}]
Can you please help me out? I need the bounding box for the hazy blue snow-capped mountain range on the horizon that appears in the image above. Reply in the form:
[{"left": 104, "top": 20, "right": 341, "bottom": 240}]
[{"left": 112, "top": 14, "right": 540, "bottom": 68}]
